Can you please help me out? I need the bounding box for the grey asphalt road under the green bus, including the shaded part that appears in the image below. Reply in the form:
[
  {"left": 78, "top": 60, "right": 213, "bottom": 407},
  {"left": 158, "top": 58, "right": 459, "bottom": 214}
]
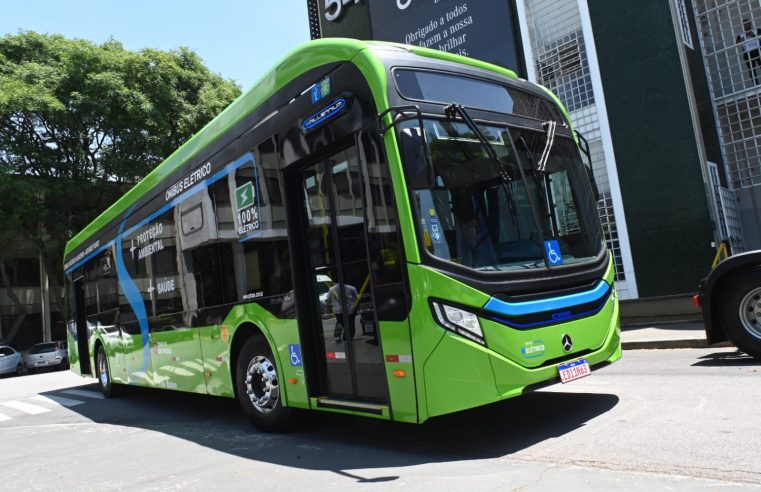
[{"left": 0, "top": 349, "right": 761, "bottom": 491}]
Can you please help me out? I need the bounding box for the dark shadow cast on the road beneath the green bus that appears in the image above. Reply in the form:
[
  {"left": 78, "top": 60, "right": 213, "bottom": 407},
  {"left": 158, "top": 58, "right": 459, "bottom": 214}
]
[{"left": 38, "top": 385, "right": 619, "bottom": 482}]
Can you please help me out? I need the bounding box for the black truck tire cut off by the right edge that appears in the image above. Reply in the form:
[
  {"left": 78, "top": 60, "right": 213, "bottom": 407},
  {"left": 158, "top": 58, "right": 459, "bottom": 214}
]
[{"left": 720, "top": 268, "right": 761, "bottom": 359}]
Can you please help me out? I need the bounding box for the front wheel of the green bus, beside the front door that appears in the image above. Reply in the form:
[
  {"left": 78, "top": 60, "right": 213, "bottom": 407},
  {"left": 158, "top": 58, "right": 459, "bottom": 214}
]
[{"left": 235, "top": 337, "right": 291, "bottom": 432}]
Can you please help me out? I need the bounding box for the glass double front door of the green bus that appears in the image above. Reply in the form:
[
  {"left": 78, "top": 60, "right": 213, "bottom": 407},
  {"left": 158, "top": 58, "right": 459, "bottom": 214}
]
[{"left": 294, "top": 142, "right": 388, "bottom": 403}]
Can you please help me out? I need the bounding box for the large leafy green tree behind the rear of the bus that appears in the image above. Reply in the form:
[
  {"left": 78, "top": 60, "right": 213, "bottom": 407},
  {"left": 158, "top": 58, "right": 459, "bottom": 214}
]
[{"left": 0, "top": 32, "right": 240, "bottom": 342}]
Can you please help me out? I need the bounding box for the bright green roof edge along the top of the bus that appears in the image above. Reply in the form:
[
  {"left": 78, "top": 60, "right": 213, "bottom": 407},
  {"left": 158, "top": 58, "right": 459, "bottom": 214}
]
[{"left": 64, "top": 38, "right": 516, "bottom": 261}]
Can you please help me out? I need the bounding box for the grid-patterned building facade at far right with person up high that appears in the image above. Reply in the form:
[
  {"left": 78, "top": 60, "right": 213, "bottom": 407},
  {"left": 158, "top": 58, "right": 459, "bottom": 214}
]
[{"left": 683, "top": 0, "right": 761, "bottom": 252}]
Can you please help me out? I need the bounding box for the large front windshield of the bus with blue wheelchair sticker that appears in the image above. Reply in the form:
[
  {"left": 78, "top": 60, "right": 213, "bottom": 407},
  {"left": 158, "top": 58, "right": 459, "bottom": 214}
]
[{"left": 401, "top": 118, "right": 602, "bottom": 271}]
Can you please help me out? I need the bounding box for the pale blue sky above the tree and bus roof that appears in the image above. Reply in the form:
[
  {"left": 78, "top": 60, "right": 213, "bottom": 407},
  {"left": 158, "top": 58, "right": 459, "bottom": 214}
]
[{"left": 0, "top": 0, "right": 309, "bottom": 90}]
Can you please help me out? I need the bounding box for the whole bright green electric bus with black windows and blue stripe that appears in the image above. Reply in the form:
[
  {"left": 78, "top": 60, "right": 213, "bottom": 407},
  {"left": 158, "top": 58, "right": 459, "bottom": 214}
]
[{"left": 64, "top": 39, "right": 621, "bottom": 430}]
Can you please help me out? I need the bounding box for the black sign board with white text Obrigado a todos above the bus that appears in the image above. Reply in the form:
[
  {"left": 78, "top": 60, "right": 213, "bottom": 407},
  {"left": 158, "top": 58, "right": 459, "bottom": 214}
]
[{"left": 309, "top": 0, "right": 525, "bottom": 75}]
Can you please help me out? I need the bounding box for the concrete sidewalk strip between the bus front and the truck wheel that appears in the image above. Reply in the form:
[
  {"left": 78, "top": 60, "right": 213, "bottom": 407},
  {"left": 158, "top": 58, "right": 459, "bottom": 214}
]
[{"left": 621, "top": 321, "right": 730, "bottom": 350}]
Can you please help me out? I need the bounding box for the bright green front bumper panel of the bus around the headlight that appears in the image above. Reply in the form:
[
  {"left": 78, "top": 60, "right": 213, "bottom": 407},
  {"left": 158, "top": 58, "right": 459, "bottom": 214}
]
[{"left": 408, "top": 256, "right": 621, "bottom": 422}]
